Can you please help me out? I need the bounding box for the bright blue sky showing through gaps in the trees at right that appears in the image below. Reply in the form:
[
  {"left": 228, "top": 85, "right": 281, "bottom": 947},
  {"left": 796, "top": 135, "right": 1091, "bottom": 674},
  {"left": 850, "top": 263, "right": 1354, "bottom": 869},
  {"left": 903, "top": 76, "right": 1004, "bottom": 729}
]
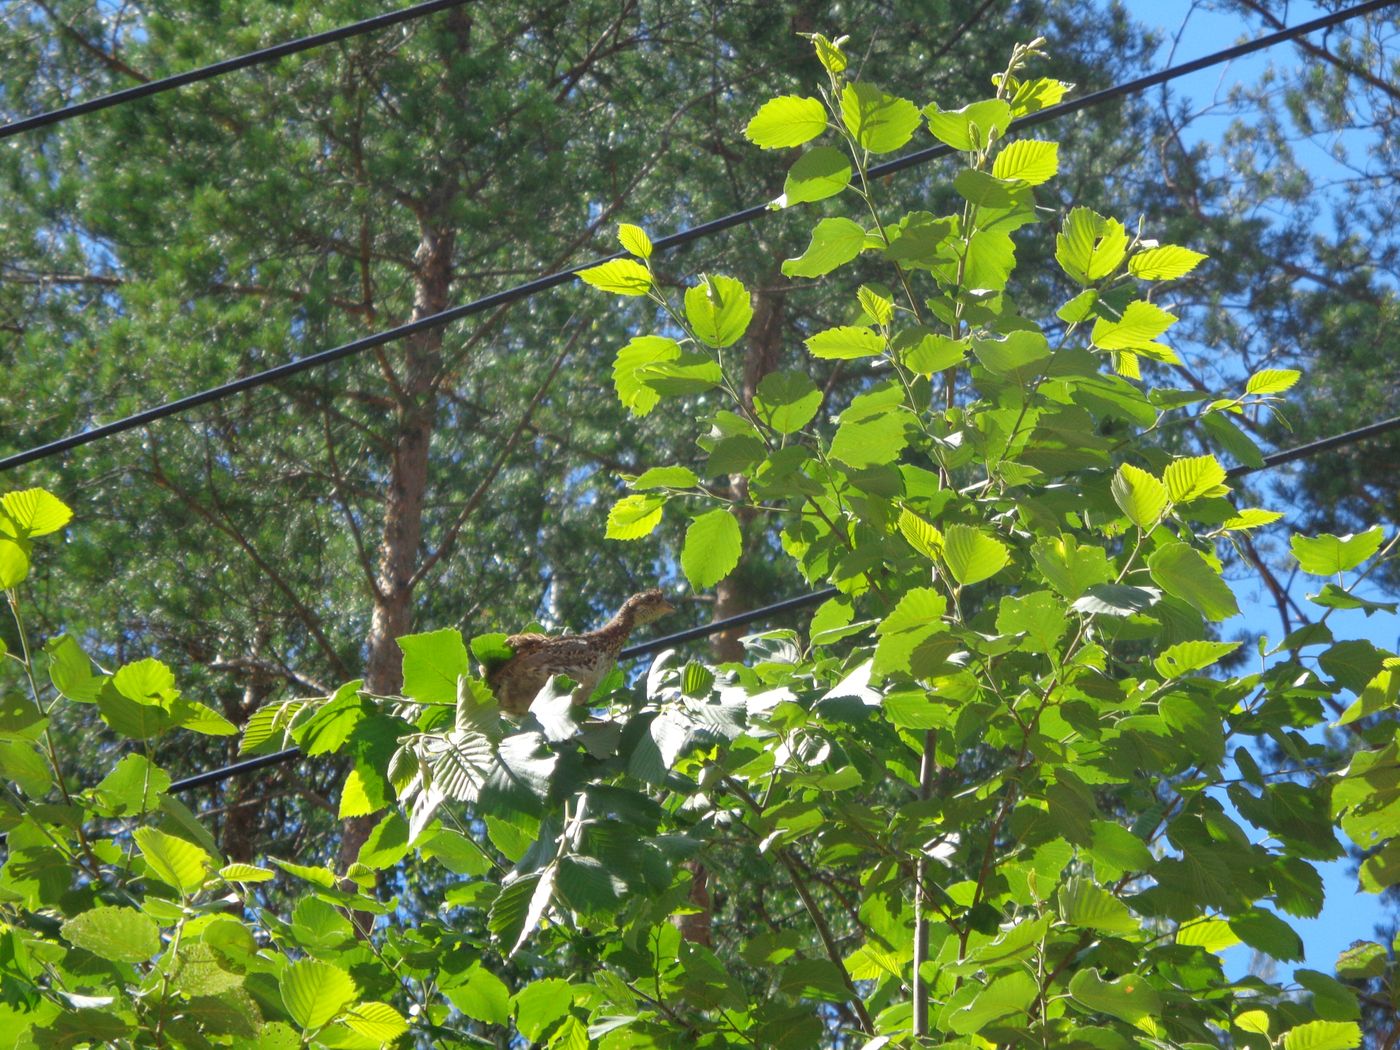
[{"left": 1126, "top": 0, "right": 1400, "bottom": 976}]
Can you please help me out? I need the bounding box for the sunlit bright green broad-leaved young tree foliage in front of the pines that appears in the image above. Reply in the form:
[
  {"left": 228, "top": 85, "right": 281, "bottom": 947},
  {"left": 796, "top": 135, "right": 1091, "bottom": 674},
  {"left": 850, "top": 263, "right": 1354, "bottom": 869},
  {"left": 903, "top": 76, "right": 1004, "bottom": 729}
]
[{"left": 0, "top": 36, "right": 1400, "bottom": 1050}]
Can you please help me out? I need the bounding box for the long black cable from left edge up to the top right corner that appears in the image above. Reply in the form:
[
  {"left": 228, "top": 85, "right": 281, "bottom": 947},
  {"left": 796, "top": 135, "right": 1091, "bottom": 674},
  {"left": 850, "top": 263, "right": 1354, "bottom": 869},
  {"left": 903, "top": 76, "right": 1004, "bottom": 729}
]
[{"left": 0, "top": 0, "right": 1400, "bottom": 472}]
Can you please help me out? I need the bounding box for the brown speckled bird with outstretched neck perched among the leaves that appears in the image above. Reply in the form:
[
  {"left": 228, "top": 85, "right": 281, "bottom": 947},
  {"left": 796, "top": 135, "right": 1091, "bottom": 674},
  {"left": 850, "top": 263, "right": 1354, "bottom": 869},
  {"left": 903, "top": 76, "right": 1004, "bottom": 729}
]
[{"left": 486, "top": 588, "right": 675, "bottom": 715}]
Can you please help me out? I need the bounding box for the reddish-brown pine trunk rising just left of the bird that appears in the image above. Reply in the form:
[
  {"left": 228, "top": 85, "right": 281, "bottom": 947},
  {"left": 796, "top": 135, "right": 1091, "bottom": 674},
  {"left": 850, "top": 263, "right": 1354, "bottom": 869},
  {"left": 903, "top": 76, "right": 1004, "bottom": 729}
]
[{"left": 340, "top": 214, "right": 455, "bottom": 928}]
